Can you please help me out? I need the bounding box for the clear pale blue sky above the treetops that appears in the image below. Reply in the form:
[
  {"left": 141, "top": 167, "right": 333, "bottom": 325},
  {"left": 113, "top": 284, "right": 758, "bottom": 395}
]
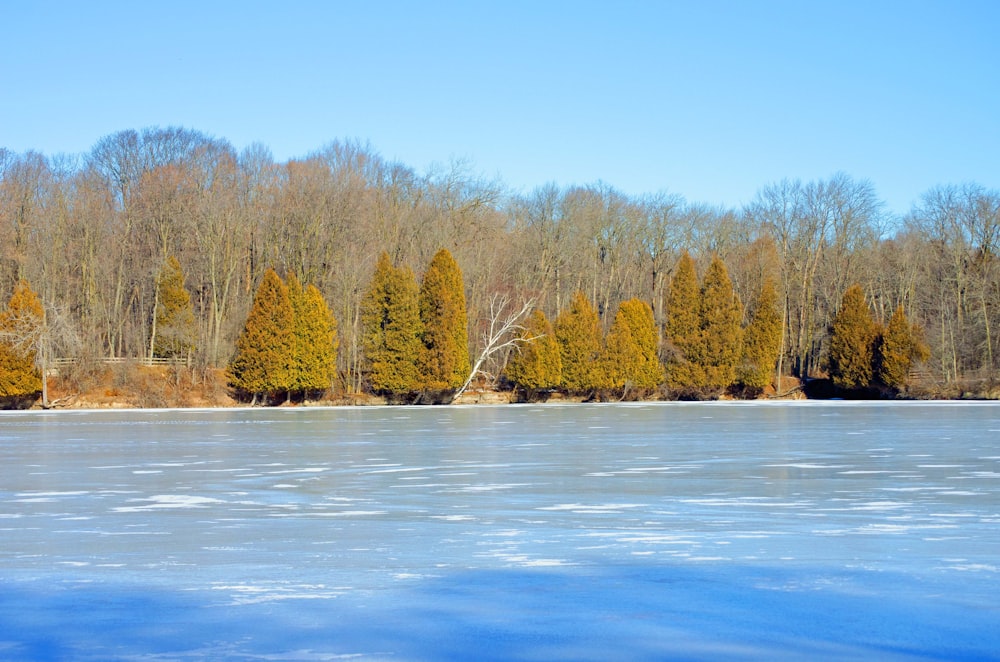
[{"left": 0, "top": 0, "right": 1000, "bottom": 213}]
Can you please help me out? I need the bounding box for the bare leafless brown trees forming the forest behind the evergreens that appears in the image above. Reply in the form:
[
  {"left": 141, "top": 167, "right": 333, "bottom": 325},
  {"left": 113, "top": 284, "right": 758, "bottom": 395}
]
[{"left": 0, "top": 128, "right": 1000, "bottom": 402}]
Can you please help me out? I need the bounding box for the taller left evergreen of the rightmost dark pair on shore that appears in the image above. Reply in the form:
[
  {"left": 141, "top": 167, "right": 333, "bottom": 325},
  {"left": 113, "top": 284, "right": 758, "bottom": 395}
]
[{"left": 830, "top": 285, "right": 879, "bottom": 389}]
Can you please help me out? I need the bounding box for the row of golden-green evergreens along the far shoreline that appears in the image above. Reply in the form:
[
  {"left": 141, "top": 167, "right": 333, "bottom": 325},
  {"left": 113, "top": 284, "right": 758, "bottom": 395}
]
[{"left": 0, "top": 248, "right": 928, "bottom": 404}]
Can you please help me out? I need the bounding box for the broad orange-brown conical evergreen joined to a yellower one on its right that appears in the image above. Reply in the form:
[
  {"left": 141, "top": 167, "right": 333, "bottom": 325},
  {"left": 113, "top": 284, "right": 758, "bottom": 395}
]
[{"left": 228, "top": 269, "right": 295, "bottom": 403}]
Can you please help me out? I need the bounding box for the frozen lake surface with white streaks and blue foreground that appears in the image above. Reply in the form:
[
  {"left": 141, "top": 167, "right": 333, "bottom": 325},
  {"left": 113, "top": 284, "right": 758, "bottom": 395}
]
[{"left": 0, "top": 403, "right": 1000, "bottom": 660}]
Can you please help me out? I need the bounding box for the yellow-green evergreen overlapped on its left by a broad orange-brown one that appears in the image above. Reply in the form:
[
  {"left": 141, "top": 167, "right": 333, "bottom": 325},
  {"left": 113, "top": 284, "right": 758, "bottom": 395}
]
[{"left": 286, "top": 273, "right": 339, "bottom": 393}]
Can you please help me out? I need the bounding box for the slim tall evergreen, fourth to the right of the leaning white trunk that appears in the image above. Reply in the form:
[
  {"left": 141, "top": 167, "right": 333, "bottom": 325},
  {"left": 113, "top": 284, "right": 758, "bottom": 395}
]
[{"left": 663, "top": 251, "right": 705, "bottom": 390}]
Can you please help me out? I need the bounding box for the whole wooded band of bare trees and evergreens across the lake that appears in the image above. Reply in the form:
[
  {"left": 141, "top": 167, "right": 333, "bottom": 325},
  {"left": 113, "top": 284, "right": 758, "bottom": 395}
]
[{"left": 0, "top": 128, "right": 1000, "bottom": 401}]
